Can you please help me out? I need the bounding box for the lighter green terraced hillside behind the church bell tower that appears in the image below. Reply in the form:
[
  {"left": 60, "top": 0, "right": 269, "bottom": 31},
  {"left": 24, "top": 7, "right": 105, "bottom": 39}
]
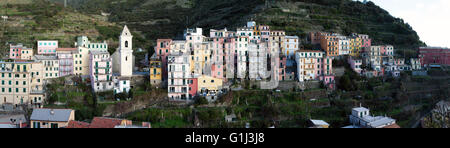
[{"left": 0, "top": 0, "right": 146, "bottom": 55}]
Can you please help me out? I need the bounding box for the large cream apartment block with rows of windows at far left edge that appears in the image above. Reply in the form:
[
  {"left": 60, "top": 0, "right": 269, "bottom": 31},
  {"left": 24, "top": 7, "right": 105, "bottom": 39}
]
[{"left": 0, "top": 62, "right": 45, "bottom": 107}]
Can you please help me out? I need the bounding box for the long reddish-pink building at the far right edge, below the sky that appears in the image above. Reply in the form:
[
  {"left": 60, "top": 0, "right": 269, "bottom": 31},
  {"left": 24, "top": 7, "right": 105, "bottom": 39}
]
[{"left": 419, "top": 47, "right": 450, "bottom": 67}]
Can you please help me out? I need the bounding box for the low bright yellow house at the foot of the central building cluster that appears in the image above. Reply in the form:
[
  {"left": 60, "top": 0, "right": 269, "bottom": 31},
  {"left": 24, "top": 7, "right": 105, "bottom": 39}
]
[{"left": 197, "top": 75, "right": 223, "bottom": 94}]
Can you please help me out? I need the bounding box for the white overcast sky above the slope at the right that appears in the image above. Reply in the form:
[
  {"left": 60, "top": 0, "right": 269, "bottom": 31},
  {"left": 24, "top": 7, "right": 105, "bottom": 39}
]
[{"left": 372, "top": 0, "right": 450, "bottom": 47}]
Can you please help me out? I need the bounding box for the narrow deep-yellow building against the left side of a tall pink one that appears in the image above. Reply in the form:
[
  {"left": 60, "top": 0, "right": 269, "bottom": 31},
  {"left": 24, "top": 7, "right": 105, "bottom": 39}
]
[{"left": 150, "top": 53, "right": 162, "bottom": 86}]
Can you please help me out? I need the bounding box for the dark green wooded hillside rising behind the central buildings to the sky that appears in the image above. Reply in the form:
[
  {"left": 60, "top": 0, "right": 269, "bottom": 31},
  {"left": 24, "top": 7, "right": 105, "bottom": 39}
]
[{"left": 53, "top": 0, "right": 424, "bottom": 49}]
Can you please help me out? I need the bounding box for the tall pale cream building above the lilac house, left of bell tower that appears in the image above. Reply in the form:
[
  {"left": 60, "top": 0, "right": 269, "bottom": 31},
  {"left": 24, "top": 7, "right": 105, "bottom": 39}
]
[{"left": 73, "top": 46, "right": 90, "bottom": 76}]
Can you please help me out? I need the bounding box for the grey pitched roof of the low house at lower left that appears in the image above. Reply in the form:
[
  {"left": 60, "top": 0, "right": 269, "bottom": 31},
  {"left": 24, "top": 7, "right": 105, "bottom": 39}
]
[{"left": 30, "top": 109, "right": 73, "bottom": 122}]
